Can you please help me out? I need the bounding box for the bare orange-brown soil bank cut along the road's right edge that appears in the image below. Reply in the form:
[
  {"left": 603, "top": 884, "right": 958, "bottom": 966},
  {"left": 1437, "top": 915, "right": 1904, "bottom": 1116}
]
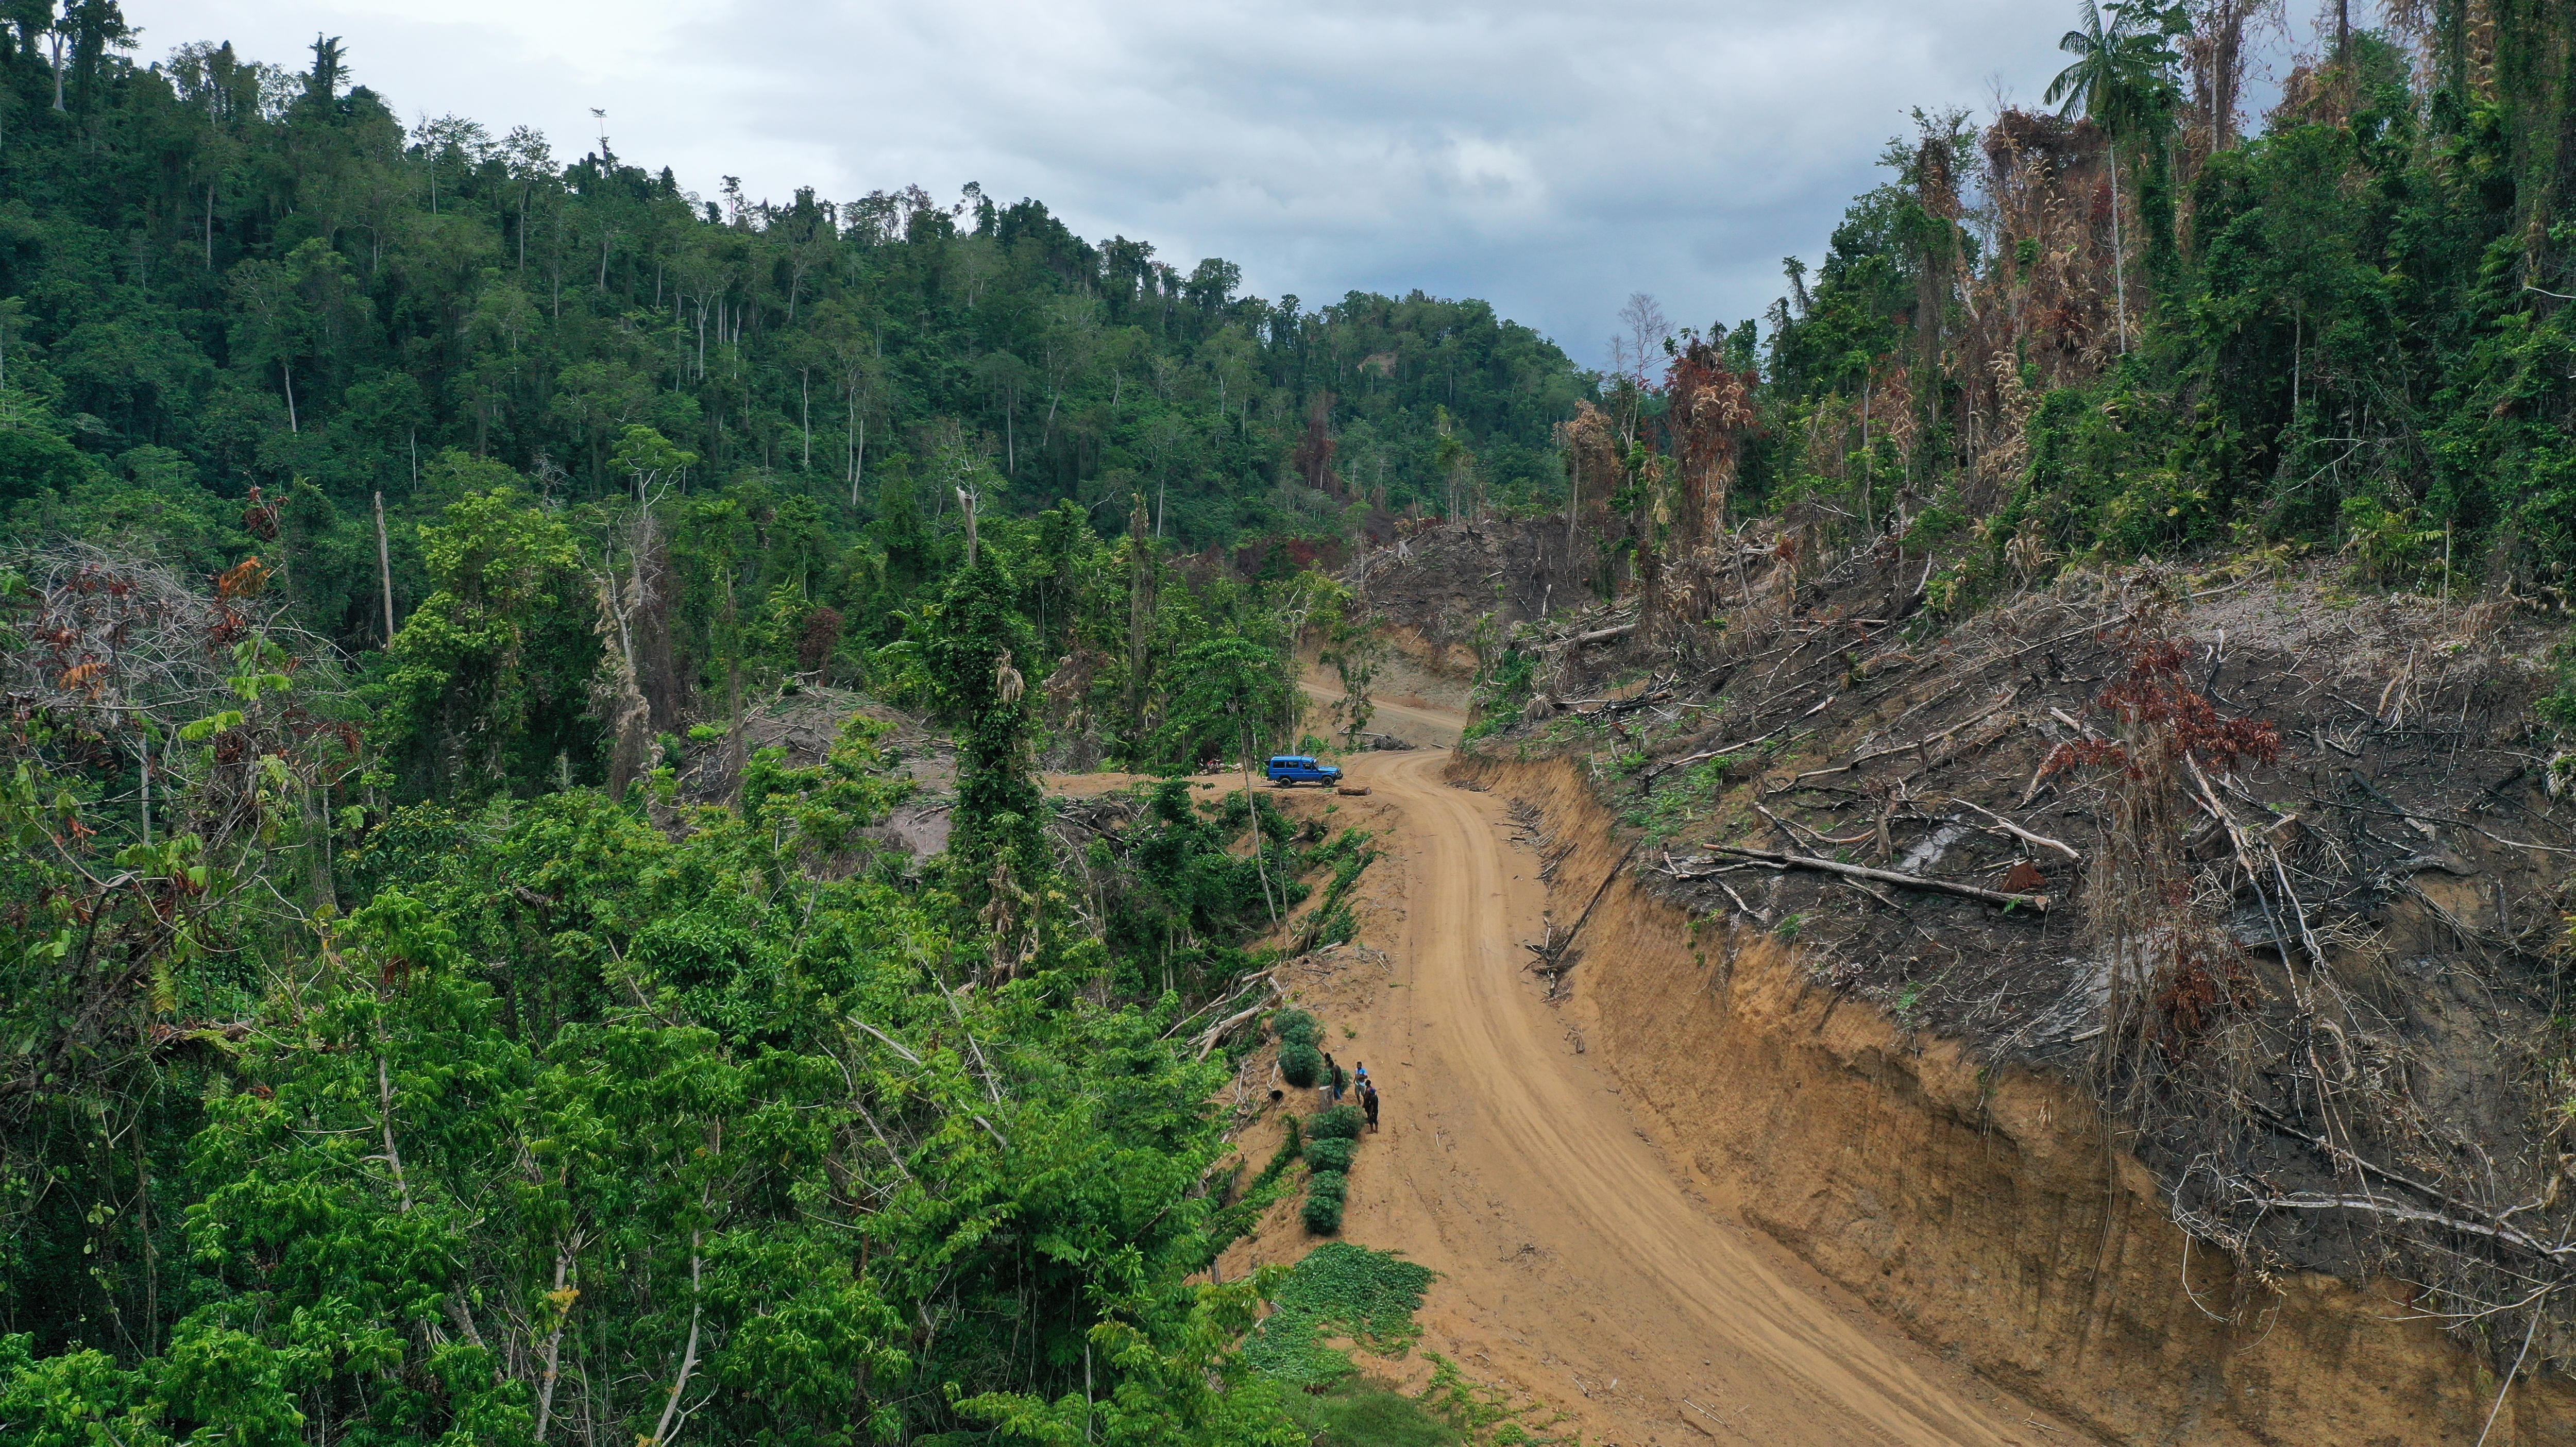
[{"left": 1453, "top": 757, "right": 2576, "bottom": 1447}]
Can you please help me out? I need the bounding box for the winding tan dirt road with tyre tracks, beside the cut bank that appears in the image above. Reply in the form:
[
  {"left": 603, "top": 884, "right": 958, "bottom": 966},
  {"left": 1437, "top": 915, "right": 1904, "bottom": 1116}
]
[{"left": 1275, "top": 752, "right": 2084, "bottom": 1447}]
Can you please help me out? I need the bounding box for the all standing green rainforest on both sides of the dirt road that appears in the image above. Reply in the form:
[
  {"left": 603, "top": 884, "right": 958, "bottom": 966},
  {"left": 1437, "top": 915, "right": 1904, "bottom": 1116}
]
[{"left": 0, "top": 0, "right": 2576, "bottom": 1447}]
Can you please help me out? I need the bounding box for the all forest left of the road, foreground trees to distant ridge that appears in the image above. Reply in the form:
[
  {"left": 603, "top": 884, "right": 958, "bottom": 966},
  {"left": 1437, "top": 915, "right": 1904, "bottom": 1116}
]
[{"left": 0, "top": 11, "right": 1589, "bottom": 1447}]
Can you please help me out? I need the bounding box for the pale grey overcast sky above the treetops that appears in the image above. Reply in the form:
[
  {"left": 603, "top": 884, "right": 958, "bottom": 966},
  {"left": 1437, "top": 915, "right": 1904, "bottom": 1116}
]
[{"left": 126, "top": 0, "right": 2329, "bottom": 366}]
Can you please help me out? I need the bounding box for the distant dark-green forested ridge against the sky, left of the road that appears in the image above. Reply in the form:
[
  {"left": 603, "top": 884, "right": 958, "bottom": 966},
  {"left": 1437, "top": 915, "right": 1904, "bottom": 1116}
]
[{"left": 0, "top": 14, "right": 1587, "bottom": 741}]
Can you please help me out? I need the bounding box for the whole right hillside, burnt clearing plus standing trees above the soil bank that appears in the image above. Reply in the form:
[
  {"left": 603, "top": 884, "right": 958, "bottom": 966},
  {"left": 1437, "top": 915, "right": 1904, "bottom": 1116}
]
[{"left": 1355, "top": 5, "right": 2576, "bottom": 1401}]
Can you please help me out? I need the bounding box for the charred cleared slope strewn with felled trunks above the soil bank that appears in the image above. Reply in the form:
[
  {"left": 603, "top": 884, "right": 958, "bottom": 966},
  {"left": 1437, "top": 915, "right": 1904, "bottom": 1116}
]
[{"left": 1481, "top": 538, "right": 2576, "bottom": 1365}]
